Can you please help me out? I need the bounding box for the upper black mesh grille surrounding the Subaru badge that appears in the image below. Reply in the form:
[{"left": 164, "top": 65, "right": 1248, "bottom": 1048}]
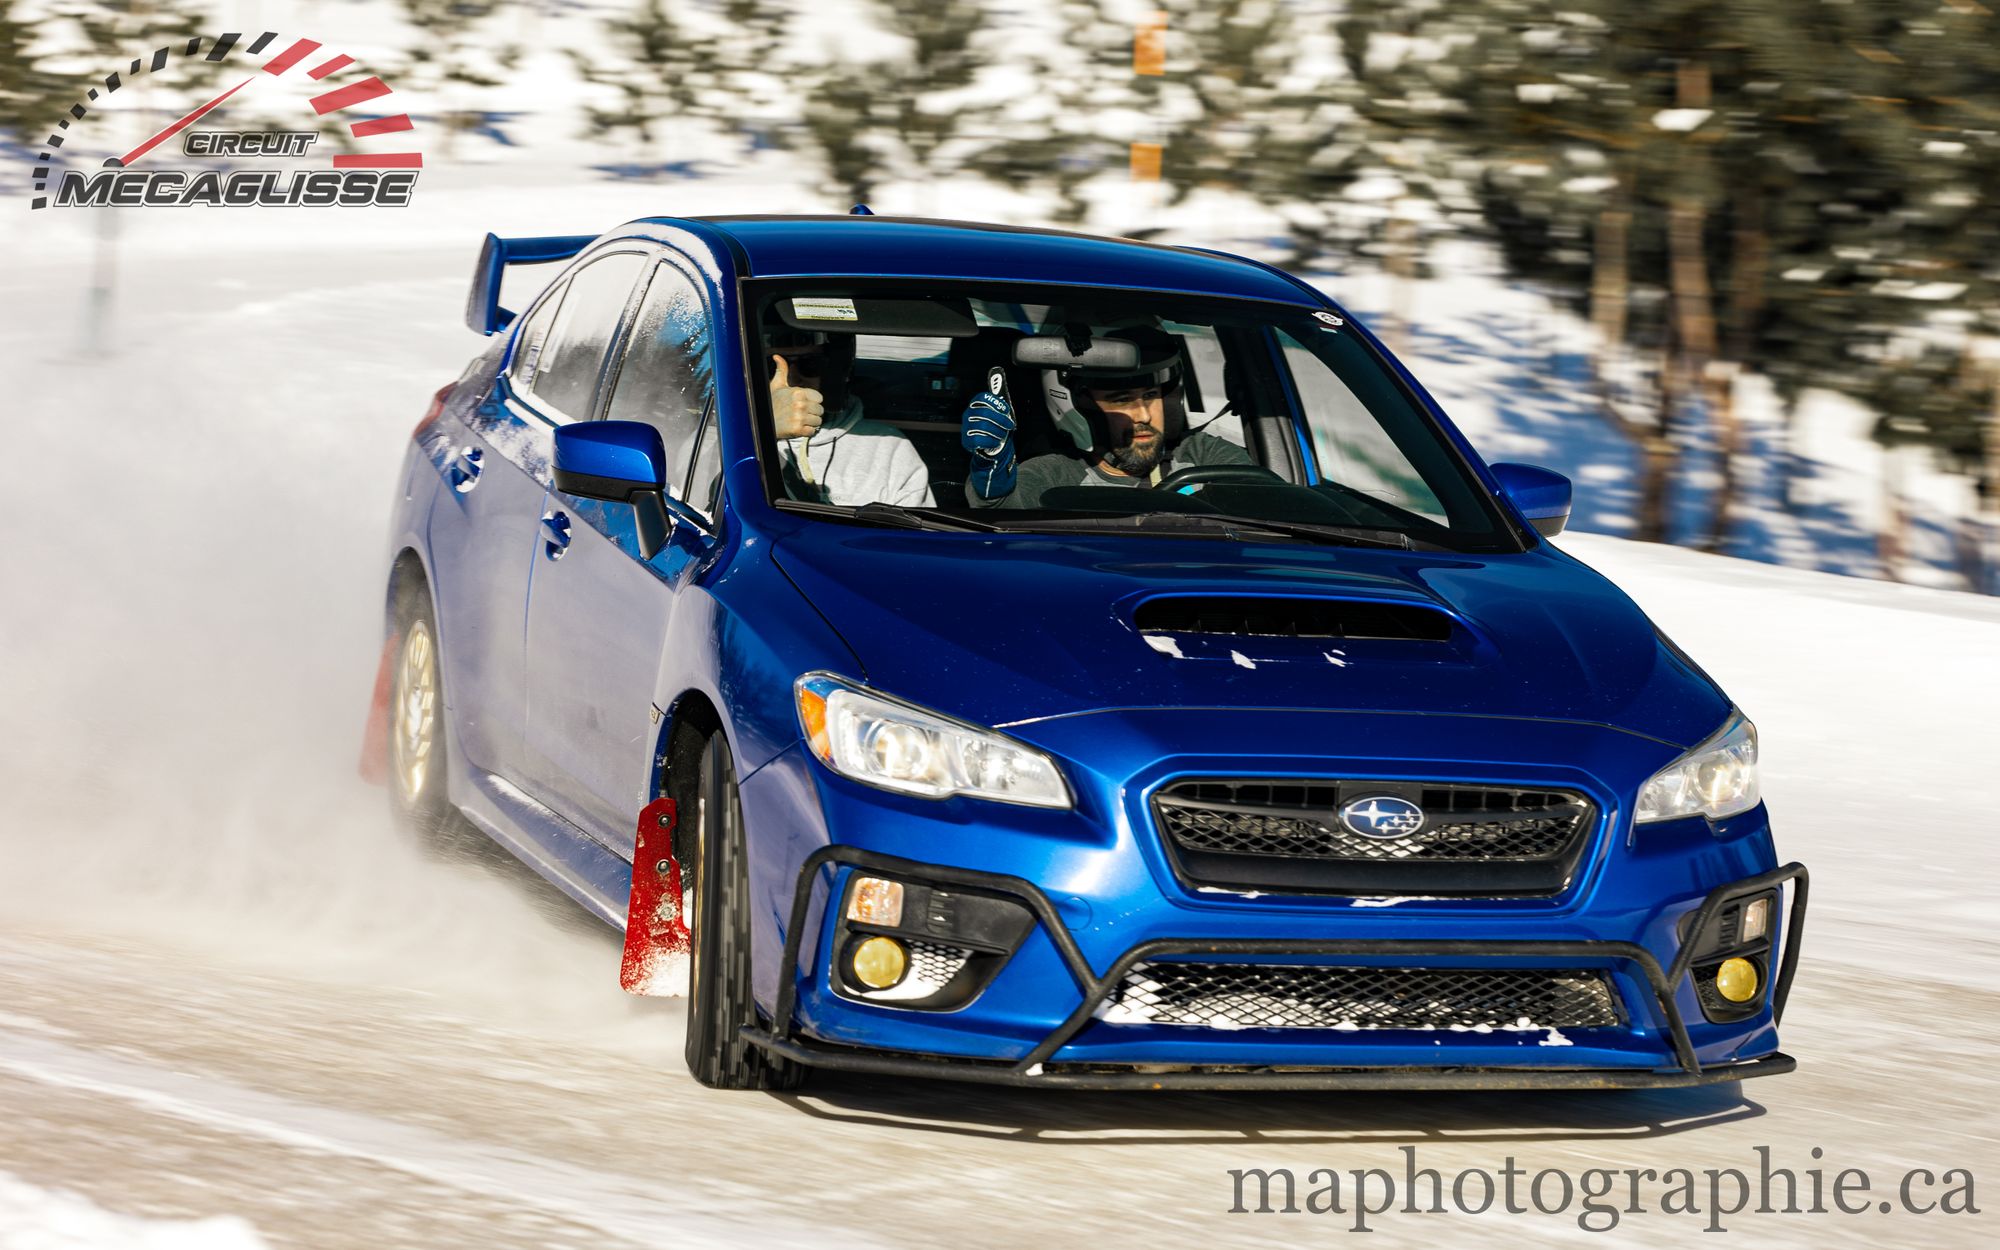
[{"left": 1152, "top": 778, "right": 1596, "bottom": 896}]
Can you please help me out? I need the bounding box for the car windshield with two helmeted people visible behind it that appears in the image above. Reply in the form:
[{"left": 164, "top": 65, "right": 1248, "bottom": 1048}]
[{"left": 748, "top": 280, "right": 1518, "bottom": 550}]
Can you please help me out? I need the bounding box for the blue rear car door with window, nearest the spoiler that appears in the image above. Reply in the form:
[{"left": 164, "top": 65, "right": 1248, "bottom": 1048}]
[{"left": 430, "top": 270, "right": 570, "bottom": 776}]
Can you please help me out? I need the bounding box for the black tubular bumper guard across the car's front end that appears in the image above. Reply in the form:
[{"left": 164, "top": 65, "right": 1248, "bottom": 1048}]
[{"left": 742, "top": 846, "right": 1808, "bottom": 1090}]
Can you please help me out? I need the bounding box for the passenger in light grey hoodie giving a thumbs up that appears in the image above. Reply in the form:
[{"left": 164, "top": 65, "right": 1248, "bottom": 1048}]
[{"left": 766, "top": 328, "right": 932, "bottom": 508}]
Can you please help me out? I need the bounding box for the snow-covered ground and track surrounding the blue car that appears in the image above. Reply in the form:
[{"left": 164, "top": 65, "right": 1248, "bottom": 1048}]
[{"left": 0, "top": 6, "right": 2000, "bottom": 1250}]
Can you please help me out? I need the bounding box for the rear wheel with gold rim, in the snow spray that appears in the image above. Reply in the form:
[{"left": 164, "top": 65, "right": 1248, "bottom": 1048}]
[{"left": 384, "top": 576, "right": 474, "bottom": 858}]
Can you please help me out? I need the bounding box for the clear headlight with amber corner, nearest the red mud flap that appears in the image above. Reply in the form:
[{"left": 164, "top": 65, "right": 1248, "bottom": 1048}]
[{"left": 792, "top": 672, "right": 1070, "bottom": 808}]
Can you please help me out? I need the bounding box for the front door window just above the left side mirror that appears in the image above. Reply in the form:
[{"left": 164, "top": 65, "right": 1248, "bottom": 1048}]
[{"left": 604, "top": 264, "right": 716, "bottom": 498}]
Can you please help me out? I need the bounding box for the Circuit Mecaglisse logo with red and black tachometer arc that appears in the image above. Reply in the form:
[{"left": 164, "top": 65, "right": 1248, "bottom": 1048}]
[{"left": 28, "top": 30, "right": 424, "bottom": 208}]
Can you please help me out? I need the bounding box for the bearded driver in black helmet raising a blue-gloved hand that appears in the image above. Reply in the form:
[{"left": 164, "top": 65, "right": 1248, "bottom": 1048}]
[{"left": 958, "top": 326, "right": 1254, "bottom": 508}]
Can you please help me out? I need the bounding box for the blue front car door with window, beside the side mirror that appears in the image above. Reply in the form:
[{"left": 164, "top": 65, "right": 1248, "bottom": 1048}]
[{"left": 528, "top": 256, "right": 714, "bottom": 850}]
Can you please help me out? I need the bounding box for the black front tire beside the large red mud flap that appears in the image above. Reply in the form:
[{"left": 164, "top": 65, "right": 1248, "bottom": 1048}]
[{"left": 676, "top": 734, "right": 808, "bottom": 1090}]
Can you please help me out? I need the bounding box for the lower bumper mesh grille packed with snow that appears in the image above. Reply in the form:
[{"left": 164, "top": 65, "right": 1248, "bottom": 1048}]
[{"left": 1098, "top": 960, "right": 1620, "bottom": 1032}]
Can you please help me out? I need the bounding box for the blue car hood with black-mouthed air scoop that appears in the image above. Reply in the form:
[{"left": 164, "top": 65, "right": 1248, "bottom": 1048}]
[{"left": 774, "top": 522, "right": 1728, "bottom": 746}]
